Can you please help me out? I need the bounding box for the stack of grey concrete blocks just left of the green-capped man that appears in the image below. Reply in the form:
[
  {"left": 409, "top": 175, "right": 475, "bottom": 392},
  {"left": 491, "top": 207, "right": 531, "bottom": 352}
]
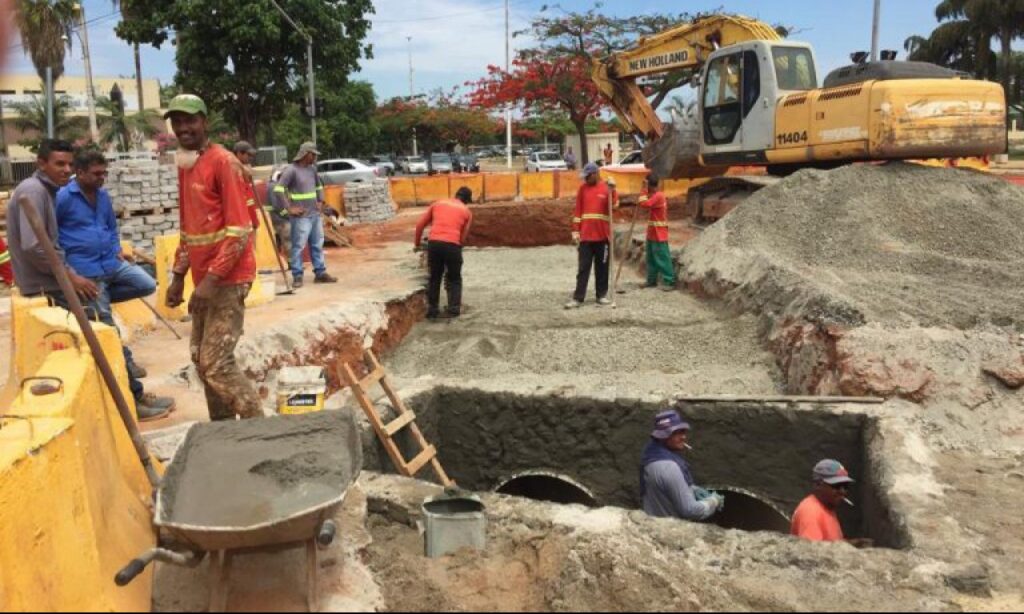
[{"left": 106, "top": 160, "right": 178, "bottom": 253}]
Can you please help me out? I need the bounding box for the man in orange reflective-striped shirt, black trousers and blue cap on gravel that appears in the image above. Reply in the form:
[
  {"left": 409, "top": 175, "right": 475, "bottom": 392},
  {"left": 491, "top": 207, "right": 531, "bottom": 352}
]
[{"left": 565, "top": 163, "right": 618, "bottom": 309}]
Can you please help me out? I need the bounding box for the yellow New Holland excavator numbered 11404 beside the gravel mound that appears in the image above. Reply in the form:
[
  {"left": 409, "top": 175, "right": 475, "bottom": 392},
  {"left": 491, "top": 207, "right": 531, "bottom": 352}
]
[{"left": 593, "top": 15, "right": 1007, "bottom": 218}]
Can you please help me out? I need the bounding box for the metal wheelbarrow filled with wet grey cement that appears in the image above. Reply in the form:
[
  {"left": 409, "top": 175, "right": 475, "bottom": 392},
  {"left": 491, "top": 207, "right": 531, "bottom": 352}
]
[{"left": 115, "top": 411, "right": 362, "bottom": 612}]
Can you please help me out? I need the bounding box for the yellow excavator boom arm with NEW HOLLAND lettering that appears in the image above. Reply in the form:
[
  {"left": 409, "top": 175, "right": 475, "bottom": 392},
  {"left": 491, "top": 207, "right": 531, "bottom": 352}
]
[{"left": 593, "top": 15, "right": 780, "bottom": 138}]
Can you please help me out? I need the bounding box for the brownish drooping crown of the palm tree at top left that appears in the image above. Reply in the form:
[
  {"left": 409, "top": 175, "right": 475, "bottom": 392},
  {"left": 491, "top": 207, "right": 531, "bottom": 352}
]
[{"left": 16, "top": 0, "right": 76, "bottom": 82}]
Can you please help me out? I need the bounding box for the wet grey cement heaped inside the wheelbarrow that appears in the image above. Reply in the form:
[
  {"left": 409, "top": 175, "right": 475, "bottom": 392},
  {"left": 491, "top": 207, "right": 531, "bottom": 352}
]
[{"left": 160, "top": 411, "right": 362, "bottom": 527}]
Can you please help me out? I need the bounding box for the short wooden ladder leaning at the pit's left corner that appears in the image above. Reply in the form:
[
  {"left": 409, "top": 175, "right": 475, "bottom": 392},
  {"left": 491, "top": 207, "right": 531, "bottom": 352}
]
[{"left": 338, "top": 350, "right": 455, "bottom": 488}]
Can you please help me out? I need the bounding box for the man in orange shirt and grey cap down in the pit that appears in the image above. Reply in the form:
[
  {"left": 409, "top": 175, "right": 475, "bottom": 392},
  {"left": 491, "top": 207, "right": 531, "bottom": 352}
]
[{"left": 790, "top": 458, "right": 872, "bottom": 547}]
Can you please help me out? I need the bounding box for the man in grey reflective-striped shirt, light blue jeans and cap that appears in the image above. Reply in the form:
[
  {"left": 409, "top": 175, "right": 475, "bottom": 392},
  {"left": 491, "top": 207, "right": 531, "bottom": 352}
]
[{"left": 273, "top": 142, "right": 338, "bottom": 288}]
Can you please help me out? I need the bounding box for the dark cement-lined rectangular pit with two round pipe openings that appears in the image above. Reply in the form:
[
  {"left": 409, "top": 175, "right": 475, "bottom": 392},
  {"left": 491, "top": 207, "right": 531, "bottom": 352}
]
[{"left": 364, "top": 387, "right": 909, "bottom": 549}]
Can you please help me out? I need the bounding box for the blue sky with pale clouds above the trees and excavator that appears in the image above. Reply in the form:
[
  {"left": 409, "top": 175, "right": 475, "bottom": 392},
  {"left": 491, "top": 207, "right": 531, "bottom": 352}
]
[{"left": 4, "top": 0, "right": 966, "bottom": 99}]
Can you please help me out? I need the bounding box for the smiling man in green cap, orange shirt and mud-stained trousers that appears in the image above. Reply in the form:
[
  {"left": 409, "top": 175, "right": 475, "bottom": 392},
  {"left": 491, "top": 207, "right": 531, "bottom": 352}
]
[{"left": 164, "top": 94, "right": 263, "bottom": 421}]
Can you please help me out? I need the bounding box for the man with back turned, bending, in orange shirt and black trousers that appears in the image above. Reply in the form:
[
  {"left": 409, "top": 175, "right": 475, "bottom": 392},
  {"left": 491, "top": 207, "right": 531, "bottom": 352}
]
[{"left": 414, "top": 187, "right": 473, "bottom": 319}]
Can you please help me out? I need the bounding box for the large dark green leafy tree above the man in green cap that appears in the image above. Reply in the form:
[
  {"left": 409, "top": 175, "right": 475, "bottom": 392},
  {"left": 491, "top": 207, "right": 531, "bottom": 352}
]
[{"left": 117, "top": 0, "right": 374, "bottom": 141}]
